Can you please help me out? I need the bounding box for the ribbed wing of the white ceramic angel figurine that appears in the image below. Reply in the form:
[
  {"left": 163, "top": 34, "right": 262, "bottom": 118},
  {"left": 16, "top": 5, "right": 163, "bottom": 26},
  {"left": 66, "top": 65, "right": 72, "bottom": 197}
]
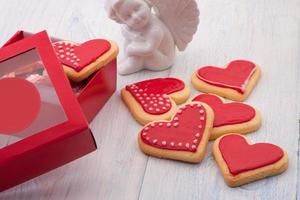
[{"left": 148, "top": 0, "right": 200, "bottom": 51}]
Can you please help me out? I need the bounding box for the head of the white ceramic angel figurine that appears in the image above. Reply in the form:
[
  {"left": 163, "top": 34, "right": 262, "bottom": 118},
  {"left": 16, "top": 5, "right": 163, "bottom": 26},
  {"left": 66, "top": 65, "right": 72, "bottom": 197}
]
[{"left": 107, "top": 0, "right": 151, "bottom": 30}]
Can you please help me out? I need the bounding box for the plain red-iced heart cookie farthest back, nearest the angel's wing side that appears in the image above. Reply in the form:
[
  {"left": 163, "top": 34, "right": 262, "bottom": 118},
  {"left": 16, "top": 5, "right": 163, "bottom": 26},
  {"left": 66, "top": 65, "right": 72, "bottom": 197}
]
[{"left": 192, "top": 60, "right": 260, "bottom": 101}]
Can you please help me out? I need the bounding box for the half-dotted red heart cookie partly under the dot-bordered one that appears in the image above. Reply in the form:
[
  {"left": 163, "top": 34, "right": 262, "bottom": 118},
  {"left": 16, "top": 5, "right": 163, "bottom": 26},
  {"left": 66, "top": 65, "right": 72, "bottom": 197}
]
[{"left": 121, "top": 78, "right": 190, "bottom": 124}]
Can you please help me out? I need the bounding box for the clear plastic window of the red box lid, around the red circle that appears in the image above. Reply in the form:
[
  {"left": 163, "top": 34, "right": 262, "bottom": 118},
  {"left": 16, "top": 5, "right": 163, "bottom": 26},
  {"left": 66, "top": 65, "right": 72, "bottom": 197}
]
[{"left": 0, "top": 49, "right": 68, "bottom": 147}]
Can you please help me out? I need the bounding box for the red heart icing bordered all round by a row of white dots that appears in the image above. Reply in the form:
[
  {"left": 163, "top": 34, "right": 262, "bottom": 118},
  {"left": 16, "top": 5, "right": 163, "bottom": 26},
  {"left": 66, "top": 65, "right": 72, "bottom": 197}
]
[{"left": 141, "top": 104, "right": 207, "bottom": 152}]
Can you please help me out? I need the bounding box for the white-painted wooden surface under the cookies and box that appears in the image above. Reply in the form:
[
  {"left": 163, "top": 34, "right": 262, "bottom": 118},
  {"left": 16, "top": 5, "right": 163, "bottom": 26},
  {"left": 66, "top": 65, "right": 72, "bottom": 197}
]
[{"left": 0, "top": 0, "right": 300, "bottom": 200}]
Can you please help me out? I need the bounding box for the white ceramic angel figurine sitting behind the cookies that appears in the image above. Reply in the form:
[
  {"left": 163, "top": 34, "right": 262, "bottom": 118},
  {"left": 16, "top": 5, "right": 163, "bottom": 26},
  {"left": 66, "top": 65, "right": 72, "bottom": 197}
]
[{"left": 106, "top": 0, "right": 199, "bottom": 75}]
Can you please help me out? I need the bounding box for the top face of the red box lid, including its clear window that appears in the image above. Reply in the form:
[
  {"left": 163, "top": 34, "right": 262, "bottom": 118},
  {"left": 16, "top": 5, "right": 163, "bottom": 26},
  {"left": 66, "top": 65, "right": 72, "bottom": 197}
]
[{"left": 0, "top": 31, "right": 88, "bottom": 156}]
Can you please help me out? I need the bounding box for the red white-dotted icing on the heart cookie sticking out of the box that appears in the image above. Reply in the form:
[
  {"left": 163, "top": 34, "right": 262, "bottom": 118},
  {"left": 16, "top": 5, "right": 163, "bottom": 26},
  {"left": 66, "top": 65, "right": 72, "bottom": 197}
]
[{"left": 53, "top": 39, "right": 111, "bottom": 72}]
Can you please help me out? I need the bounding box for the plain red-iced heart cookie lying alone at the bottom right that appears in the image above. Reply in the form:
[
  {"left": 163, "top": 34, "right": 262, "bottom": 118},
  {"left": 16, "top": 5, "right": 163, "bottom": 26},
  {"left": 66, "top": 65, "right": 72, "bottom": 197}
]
[{"left": 213, "top": 134, "right": 288, "bottom": 187}]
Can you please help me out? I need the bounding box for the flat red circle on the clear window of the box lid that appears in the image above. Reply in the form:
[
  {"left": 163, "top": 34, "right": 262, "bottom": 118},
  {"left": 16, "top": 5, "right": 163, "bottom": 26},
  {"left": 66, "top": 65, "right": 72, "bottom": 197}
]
[{"left": 0, "top": 78, "right": 41, "bottom": 134}]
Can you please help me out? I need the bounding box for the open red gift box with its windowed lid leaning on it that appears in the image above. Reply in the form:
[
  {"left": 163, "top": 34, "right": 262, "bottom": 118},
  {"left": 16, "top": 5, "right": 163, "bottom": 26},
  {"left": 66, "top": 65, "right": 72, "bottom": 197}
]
[{"left": 0, "top": 31, "right": 116, "bottom": 191}]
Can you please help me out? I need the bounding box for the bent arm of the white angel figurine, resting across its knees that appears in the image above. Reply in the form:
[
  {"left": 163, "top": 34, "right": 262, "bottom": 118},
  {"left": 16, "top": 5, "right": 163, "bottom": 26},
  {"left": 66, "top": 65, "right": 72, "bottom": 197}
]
[{"left": 127, "top": 26, "right": 164, "bottom": 56}]
